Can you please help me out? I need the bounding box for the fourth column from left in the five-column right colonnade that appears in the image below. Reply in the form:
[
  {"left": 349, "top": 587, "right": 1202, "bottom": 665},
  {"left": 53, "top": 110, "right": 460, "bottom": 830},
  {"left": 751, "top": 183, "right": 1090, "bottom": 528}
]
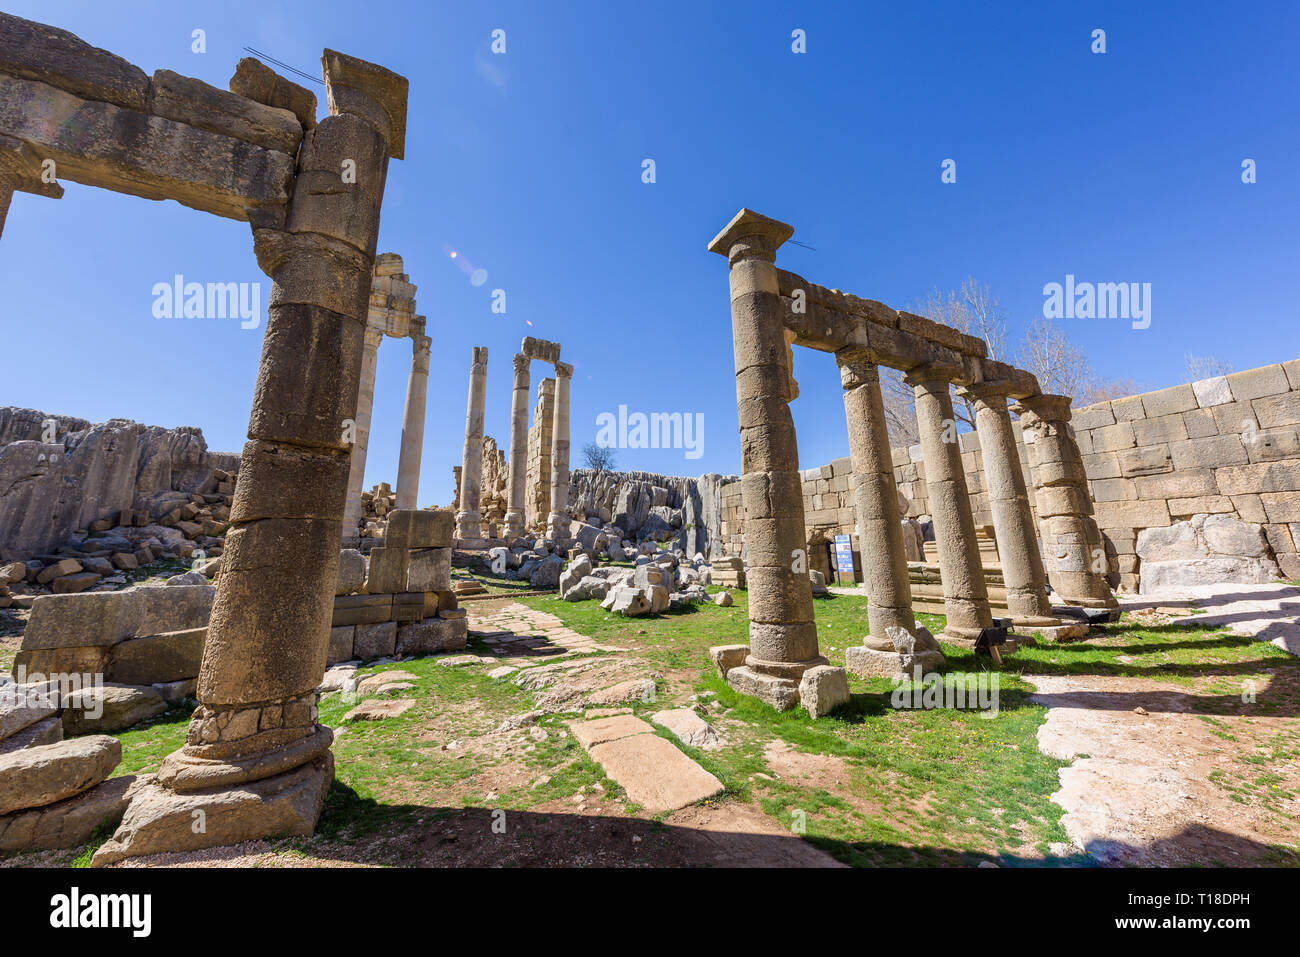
[{"left": 962, "top": 382, "right": 1061, "bottom": 629}]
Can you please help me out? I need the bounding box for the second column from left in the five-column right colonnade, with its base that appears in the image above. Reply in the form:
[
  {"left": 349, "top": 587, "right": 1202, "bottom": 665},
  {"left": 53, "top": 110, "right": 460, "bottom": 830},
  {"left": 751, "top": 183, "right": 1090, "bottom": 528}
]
[{"left": 835, "top": 348, "right": 943, "bottom": 675}]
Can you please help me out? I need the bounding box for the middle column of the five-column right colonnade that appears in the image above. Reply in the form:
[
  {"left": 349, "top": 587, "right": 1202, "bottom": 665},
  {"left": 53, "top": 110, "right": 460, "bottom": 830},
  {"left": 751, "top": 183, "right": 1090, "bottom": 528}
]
[{"left": 905, "top": 363, "right": 993, "bottom": 648}]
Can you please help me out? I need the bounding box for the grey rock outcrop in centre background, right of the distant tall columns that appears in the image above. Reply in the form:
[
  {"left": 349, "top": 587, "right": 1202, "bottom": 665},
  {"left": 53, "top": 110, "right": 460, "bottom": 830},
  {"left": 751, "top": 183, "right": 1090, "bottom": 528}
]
[{"left": 569, "top": 468, "right": 737, "bottom": 555}]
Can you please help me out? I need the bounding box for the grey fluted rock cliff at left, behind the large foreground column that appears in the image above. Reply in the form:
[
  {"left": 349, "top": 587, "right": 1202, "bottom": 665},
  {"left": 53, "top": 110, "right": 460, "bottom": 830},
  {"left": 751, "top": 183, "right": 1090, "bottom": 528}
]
[{"left": 0, "top": 407, "right": 239, "bottom": 560}]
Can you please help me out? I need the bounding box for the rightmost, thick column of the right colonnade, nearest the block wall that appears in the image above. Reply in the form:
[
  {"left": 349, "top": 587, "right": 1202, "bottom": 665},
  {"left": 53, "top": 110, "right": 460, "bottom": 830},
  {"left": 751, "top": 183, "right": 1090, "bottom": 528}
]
[{"left": 1015, "top": 395, "right": 1119, "bottom": 609}]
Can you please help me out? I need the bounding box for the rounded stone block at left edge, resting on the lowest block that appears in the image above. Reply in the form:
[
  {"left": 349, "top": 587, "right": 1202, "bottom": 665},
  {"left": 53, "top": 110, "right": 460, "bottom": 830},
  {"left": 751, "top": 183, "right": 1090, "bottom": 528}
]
[{"left": 0, "top": 735, "right": 122, "bottom": 815}]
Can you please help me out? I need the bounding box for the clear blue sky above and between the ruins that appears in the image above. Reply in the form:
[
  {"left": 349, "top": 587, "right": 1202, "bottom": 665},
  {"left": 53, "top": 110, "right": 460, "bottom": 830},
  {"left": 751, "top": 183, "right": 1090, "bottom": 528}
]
[{"left": 0, "top": 0, "right": 1300, "bottom": 505}]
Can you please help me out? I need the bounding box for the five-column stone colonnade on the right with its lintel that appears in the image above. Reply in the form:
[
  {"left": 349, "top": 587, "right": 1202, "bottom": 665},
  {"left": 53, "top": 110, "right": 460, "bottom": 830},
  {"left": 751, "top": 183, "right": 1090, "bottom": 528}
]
[{"left": 709, "top": 209, "right": 1117, "bottom": 701}]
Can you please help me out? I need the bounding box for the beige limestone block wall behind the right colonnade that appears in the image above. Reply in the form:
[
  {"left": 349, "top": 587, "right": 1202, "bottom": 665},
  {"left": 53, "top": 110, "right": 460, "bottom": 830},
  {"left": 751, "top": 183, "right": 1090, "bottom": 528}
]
[{"left": 720, "top": 359, "right": 1300, "bottom": 592}]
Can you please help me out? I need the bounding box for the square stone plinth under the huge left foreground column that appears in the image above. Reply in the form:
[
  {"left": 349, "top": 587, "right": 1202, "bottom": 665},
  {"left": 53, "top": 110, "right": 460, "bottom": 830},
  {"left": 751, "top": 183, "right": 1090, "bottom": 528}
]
[{"left": 91, "top": 752, "right": 334, "bottom": 867}]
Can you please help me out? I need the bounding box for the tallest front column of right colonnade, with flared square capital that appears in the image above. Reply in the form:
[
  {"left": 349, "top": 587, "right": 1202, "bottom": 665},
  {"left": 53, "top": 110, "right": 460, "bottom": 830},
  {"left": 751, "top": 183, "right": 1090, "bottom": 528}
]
[{"left": 709, "top": 209, "right": 826, "bottom": 709}]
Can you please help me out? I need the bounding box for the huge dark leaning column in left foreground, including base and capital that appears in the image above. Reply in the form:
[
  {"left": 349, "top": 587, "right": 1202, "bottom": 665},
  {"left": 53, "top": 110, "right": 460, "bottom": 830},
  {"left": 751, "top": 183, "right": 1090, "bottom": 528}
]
[{"left": 95, "top": 51, "right": 407, "bottom": 863}]
